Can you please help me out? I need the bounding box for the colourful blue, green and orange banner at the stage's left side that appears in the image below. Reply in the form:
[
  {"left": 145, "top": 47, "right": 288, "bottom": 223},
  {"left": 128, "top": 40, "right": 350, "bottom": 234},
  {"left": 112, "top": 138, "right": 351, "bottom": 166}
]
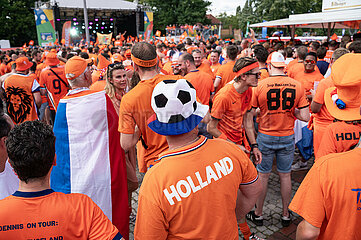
[{"left": 34, "top": 8, "right": 56, "bottom": 46}]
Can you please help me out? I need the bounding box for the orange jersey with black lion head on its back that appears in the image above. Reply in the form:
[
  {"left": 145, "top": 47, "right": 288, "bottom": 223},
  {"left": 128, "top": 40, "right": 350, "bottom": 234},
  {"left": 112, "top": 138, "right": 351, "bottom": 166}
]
[{"left": 4, "top": 73, "right": 40, "bottom": 124}]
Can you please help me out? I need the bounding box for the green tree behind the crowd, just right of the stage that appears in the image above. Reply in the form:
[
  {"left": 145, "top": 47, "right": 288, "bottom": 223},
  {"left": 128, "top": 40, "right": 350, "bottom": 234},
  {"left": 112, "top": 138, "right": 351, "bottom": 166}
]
[{"left": 141, "top": 0, "right": 211, "bottom": 30}]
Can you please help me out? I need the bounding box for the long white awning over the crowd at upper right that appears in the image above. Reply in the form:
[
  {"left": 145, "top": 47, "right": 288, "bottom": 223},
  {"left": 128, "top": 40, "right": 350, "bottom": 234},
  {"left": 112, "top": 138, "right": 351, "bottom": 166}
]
[{"left": 250, "top": 8, "right": 361, "bottom": 29}]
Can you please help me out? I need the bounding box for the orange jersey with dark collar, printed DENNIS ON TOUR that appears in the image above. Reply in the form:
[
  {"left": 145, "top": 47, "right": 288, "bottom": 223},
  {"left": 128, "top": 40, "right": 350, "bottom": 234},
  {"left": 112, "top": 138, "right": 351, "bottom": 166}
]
[{"left": 0, "top": 189, "right": 122, "bottom": 240}]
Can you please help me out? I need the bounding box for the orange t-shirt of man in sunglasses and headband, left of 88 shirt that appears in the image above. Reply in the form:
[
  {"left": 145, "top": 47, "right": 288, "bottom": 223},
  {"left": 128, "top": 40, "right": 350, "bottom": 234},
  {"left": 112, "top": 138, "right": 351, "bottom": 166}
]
[{"left": 211, "top": 84, "right": 252, "bottom": 143}]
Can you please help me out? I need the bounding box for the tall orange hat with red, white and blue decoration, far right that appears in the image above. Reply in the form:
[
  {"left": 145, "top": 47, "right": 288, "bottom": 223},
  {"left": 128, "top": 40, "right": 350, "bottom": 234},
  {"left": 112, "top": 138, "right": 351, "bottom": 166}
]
[{"left": 324, "top": 53, "right": 361, "bottom": 121}]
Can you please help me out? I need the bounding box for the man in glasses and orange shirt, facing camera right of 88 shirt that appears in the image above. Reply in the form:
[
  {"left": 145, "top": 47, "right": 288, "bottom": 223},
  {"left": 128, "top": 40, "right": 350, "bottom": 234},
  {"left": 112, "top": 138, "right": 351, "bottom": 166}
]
[{"left": 293, "top": 52, "right": 323, "bottom": 102}]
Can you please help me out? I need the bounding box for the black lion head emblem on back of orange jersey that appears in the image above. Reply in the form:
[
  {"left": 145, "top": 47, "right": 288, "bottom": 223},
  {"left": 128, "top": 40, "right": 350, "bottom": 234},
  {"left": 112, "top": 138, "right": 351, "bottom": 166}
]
[{"left": 6, "top": 87, "right": 32, "bottom": 124}]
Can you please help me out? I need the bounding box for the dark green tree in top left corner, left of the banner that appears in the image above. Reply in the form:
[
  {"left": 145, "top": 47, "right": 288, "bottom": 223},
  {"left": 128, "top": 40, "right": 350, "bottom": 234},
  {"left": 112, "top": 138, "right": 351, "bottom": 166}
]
[{"left": 0, "top": 0, "right": 45, "bottom": 46}]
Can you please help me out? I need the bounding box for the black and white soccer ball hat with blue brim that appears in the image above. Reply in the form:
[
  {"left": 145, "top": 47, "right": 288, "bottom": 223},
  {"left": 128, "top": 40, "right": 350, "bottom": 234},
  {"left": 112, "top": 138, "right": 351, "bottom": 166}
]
[{"left": 148, "top": 79, "right": 209, "bottom": 136}]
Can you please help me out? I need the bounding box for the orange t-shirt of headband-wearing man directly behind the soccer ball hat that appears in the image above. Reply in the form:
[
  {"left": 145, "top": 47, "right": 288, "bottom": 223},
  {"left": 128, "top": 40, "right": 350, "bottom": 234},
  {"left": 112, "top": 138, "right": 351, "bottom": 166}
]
[{"left": 118, "top": 74, "right": 180, "bottom": 172}]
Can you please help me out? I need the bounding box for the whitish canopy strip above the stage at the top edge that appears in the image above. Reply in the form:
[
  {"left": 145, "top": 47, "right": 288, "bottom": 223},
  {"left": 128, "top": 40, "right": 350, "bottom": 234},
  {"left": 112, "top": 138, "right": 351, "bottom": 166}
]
[{"left": 51, "top": 0, "right": 138, "bottom": 10}]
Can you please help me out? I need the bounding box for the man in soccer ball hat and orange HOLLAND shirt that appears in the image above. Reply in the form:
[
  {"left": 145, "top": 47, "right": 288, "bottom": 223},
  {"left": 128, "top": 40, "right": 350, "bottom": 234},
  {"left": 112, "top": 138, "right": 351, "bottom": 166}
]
[{"left": 134, "top": 79, "right": 260, "bottom": 240}]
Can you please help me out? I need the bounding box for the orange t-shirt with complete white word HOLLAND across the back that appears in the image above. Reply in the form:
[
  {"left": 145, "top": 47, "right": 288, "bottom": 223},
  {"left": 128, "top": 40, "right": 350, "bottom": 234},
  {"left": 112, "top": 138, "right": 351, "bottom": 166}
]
[{"left": 134, "top": 136, "right": 258, "bottom": 240}]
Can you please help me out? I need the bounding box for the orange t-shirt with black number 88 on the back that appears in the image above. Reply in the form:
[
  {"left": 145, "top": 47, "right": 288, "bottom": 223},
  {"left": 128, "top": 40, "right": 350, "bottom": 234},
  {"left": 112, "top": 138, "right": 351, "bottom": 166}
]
[{"left": 252, "top": 76, "right": 308, "bottom": 136}]
